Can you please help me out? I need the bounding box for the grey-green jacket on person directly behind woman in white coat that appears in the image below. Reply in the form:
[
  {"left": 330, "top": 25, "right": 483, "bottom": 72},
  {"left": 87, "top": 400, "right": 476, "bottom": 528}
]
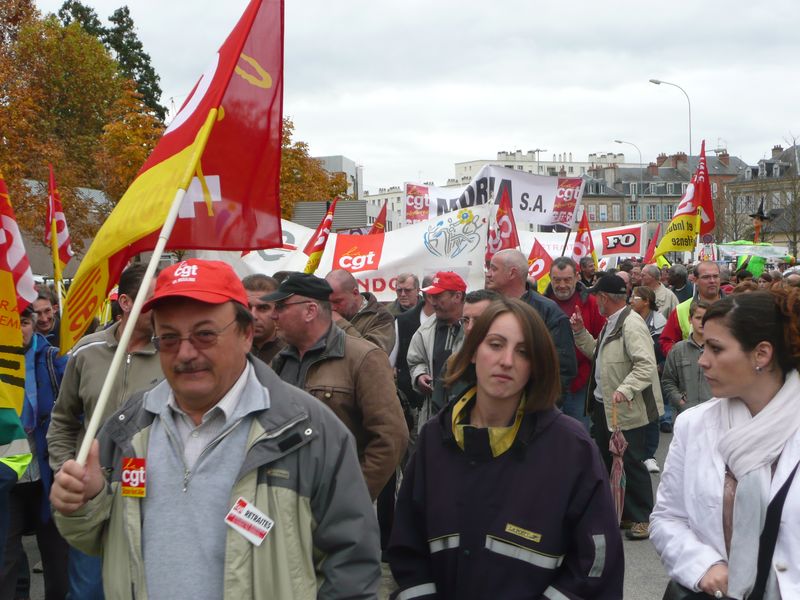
[{"left": 661, "top": 336, "right": 712, "bottom": 413}]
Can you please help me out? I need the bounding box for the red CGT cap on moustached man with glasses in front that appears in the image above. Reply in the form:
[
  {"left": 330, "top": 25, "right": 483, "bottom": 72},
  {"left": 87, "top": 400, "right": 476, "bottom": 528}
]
[{"left": 142, "top": 258, "right": 247, "bottom": 311}]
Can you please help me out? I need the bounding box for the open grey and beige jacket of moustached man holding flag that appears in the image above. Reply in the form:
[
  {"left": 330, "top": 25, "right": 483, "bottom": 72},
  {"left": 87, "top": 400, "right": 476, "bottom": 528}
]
[{"left": 55, "top": 360, "right": 380, "bottom": 600}]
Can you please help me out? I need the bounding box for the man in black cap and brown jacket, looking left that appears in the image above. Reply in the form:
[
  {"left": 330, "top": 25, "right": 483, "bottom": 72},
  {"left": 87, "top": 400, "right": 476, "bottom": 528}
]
[{"left": 268, "top": 273, "right": 408, "bottom": 500}]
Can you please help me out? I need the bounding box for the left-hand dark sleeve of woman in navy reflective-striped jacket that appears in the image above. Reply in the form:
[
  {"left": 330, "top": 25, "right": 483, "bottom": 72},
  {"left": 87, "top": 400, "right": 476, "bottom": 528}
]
[{"left": 387, "top": 424, "right": 438, "bottom": 600}]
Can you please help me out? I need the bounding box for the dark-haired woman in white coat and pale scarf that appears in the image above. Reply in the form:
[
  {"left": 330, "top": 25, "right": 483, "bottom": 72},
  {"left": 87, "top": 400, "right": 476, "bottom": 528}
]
[{"left": 650, "top": 289, "right": 800, "bottom": 600}]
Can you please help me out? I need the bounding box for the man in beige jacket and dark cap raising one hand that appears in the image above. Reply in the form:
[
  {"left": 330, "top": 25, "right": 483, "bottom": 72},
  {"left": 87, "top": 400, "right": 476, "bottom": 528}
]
[{"left": 570, "top": 275, "right": 664, "bottom": 539}]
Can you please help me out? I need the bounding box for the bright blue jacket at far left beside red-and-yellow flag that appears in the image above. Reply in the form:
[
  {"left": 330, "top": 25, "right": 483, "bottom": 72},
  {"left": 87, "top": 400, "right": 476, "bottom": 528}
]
[{"left": 22, "top": 333, "right": 67, "bottom": 520}]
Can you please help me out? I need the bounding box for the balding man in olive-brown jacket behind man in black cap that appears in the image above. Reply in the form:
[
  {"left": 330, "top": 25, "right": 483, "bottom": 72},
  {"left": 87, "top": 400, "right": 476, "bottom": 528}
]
[{"left": 325, "top": 269, "right": 395, "bottom": 355}]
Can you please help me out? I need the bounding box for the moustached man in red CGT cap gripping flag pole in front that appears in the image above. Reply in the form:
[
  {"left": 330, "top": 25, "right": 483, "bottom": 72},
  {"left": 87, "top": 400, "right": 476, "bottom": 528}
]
[{"left": 51, "top": 259, "right": 380, "bottom": 600}]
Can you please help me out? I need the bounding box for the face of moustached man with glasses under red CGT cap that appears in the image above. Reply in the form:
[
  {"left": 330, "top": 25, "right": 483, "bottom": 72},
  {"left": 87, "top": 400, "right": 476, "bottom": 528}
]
[{"left": 153, "top": 298, "right": 253, "bottom": 410}]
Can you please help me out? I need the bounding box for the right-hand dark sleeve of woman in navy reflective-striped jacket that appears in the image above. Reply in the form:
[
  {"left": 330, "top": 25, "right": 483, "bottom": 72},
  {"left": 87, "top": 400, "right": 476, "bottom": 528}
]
[{"left": 544, "top": 440, "right": 625, "bottom": 600}]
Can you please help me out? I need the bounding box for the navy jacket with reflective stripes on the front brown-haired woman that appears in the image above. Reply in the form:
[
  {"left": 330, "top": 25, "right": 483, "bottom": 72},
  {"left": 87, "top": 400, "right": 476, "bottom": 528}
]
[{"left": 388, "top": 396, "right": 624, "bottom": 600}]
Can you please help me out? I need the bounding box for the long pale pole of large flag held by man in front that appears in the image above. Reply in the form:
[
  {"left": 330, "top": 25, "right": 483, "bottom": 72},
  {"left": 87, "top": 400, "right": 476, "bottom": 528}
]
[{"left": 76, "top": 108, "right": 217, "bottom": 466}]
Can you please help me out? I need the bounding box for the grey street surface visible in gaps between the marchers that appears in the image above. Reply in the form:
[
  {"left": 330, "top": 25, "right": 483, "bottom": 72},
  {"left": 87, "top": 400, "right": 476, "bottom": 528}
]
[{"left": 25, "top": 433, "right": 672, "bottom": 600}]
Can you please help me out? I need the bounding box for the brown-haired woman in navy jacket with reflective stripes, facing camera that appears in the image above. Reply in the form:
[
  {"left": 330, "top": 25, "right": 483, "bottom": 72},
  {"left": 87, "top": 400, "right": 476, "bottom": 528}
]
[{"left": 388, "top": 299, "right": 623, "bottom": 600}]
